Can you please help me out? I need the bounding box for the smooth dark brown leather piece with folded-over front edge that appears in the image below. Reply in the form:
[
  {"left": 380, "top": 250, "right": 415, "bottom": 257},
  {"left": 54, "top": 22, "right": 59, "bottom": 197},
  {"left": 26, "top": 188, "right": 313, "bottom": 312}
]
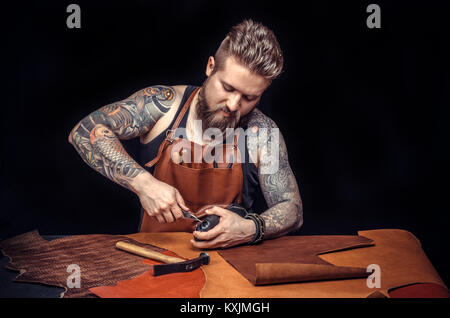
[{"left": 219, "top": 235, "right": 373, "bottom": 285}]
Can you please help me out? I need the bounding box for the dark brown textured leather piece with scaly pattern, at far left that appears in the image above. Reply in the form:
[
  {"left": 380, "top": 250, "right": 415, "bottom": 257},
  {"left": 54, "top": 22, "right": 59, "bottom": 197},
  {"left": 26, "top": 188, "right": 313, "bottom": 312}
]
[{"left": 0, "top": 231, "right": 164, "bottom": 298}]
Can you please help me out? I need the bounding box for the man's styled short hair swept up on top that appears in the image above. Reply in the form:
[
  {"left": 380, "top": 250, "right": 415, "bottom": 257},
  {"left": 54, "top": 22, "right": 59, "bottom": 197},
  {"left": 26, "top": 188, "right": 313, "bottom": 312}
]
[{"left": 214, "top": 20, "right": 283, "bottom": 80}]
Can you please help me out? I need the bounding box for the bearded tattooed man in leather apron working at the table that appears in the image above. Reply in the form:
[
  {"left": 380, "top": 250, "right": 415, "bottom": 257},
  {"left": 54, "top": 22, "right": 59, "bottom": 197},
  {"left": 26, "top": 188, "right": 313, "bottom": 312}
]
[{"left": 69, "top": 20, "right": 303, "bottom": 249}]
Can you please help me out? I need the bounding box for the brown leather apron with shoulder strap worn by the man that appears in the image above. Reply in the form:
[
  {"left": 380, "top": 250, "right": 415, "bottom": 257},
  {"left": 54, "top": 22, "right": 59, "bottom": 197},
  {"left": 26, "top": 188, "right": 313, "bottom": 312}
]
[{"left": 140, "top": 88, "right": 243, "bottom": 232}]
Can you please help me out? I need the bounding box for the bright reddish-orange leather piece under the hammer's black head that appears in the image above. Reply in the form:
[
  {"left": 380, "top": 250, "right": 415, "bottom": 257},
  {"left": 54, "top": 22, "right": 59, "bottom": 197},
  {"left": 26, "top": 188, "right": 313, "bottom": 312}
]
[{"left": 89, "top": 251, "right": 206, "bottom": 298}]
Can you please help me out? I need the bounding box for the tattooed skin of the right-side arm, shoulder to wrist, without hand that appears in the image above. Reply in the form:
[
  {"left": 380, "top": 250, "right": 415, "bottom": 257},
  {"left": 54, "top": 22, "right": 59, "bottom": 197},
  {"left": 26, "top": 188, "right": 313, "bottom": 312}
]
[{"left": 245, "top": 109, "right": 303, "bottom": 238}]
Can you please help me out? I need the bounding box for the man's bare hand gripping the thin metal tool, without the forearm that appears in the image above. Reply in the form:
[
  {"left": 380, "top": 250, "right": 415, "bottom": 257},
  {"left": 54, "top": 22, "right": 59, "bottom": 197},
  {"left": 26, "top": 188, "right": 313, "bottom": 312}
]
[{"left": 133, "top": 173, "right": 189, "bottom": 223}]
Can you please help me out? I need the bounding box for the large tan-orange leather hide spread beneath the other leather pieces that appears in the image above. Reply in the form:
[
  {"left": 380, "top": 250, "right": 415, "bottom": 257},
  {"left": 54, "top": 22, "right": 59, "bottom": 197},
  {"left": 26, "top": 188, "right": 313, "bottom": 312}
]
[{"left": 128, "top": 229, "right": 447, "bottom": 298}]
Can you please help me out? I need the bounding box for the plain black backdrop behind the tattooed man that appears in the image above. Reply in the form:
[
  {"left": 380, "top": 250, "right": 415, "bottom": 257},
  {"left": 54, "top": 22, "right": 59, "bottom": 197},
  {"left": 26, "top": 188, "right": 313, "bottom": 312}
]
[{"left": 0, "top": 0, "right": 450, "bottom": 283}]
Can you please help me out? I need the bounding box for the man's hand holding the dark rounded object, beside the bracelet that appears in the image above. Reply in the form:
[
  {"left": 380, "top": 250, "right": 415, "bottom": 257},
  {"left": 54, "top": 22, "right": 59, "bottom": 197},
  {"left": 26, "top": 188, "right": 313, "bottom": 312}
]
[{"left": 191, "top": 206, "right": 256, "bottom": 249}]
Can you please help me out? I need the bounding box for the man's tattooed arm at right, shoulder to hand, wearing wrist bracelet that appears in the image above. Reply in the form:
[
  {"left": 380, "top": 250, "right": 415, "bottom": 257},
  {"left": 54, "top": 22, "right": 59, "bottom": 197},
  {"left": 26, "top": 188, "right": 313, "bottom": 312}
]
[{"left": 191, "top": 109, "right": 303, "bottom": 249}]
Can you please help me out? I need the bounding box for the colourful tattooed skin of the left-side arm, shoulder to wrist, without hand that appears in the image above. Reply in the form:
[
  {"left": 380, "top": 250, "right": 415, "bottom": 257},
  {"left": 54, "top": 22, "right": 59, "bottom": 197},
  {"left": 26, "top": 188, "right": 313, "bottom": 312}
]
[{"left": 69, "top": 86, "right": 175, "bottom": 188}]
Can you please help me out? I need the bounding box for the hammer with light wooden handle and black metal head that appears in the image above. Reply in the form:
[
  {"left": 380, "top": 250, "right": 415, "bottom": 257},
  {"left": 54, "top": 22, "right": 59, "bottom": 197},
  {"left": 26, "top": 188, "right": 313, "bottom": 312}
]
[{"left": 116, "top": 241, "right": 209, "bottom": 276}]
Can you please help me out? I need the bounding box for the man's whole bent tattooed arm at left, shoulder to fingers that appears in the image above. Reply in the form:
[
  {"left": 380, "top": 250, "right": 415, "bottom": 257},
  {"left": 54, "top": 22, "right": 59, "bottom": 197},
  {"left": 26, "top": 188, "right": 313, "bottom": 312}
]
[{"left": 69, "top": 86, "right": 190, "bottom": 222}]
